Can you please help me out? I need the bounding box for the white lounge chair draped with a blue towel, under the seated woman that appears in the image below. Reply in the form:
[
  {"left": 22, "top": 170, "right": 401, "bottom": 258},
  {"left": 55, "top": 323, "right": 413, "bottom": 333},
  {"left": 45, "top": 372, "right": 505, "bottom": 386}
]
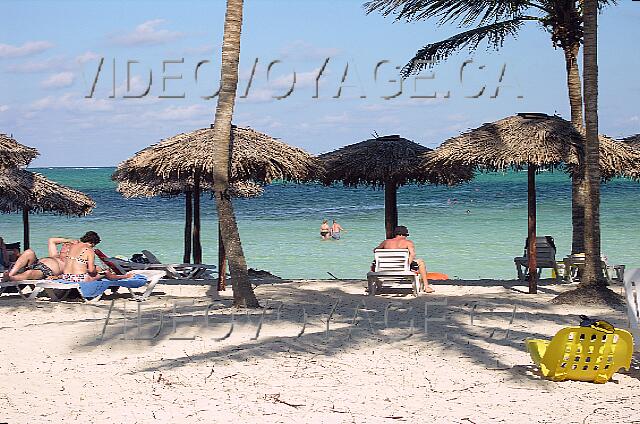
[{"left": 29, "top": 270, "right": 165, "bottom": 302}]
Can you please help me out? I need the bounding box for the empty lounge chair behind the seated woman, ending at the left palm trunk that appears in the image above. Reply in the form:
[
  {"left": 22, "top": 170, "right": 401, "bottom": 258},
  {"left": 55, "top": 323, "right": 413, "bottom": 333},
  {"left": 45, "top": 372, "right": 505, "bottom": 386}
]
[{"left": 95, "top": 249, "right": 216, "bottom": 280}]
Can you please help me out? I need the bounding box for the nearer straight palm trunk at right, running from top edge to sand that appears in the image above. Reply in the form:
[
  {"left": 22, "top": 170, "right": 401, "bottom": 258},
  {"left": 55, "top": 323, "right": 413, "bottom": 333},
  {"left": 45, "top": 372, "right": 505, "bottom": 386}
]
[{"left": 580, "top": 0, "right": 606, "bottom": 286}]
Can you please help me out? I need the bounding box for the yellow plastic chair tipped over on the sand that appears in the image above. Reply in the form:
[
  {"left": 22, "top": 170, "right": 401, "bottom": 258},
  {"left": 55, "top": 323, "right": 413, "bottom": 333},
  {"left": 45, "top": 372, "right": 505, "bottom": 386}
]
[{"left": 527, "top": 327, "right": 633, "bottom": 383}]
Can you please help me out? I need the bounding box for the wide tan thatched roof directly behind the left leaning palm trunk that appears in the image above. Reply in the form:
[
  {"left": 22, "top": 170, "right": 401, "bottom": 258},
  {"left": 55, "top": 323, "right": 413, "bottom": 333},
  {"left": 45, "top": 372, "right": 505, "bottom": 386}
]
[{"left": 113, "top": 126, "right": 320, "bottom": 184}]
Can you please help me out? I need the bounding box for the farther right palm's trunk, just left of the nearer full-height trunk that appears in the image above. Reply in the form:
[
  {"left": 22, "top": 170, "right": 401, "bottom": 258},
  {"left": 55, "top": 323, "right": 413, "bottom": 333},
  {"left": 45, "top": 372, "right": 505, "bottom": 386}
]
[{"left": 564, "top": 43, "right": 586, "bottom": 253}]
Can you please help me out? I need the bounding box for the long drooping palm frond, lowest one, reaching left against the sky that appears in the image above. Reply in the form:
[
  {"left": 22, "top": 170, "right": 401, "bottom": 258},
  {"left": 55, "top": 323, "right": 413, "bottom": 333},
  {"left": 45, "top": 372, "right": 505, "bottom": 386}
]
[{"left": 401, "top": 16, "right": 537, "bottom": 77}]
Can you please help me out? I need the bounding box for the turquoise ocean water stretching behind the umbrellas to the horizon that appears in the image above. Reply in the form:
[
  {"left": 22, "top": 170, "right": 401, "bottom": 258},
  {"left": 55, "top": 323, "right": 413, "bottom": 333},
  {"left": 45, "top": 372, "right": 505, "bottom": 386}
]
[{"left": 0, "top": 168, "right": 640, "bottom": 279}]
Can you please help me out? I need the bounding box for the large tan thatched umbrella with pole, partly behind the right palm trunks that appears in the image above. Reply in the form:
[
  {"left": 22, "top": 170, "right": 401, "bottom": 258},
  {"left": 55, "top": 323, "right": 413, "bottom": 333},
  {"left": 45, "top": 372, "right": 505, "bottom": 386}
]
[{"left": 422, "top": 113, "right": 640, "bottom": 293}]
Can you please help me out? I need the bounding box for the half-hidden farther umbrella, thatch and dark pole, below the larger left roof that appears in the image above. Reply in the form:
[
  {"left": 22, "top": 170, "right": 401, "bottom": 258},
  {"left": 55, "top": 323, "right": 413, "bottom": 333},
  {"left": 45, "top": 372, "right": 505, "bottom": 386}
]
[{"left": 117, "top": 179, "right": 264, "bottom": 262}]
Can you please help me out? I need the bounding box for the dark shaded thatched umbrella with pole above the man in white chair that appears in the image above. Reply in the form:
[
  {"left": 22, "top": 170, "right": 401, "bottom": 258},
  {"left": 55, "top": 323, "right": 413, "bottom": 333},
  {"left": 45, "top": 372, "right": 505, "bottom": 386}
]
[{"left": 319, "top": 135, "right": 473, "bottom": 238}]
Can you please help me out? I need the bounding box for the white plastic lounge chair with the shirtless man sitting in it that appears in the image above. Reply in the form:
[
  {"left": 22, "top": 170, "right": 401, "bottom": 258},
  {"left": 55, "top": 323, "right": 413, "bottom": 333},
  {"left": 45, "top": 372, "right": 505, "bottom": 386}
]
[{"left": 367, "top": 249, "right": 422, "bottom": 297}]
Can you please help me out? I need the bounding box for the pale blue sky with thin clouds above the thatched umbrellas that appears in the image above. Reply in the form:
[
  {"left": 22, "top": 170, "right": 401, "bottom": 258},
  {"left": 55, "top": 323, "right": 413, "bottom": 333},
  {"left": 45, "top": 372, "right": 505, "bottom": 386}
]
[{"left": 0, "top": 0, "right": 640, "bottom": 167}]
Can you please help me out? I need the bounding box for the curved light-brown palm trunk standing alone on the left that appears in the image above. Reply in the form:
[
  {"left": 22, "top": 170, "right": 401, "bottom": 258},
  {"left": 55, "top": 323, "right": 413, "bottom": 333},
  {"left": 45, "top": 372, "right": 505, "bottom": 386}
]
[{"left": 213, "top": 0, "right": 260, "bottom": 308}]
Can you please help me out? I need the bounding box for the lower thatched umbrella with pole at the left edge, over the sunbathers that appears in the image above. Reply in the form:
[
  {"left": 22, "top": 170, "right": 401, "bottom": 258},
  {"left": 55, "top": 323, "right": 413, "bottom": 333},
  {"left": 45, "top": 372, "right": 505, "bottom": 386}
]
[{"left": 0, "top": 168, "right": 96, "bottom": 249}]
